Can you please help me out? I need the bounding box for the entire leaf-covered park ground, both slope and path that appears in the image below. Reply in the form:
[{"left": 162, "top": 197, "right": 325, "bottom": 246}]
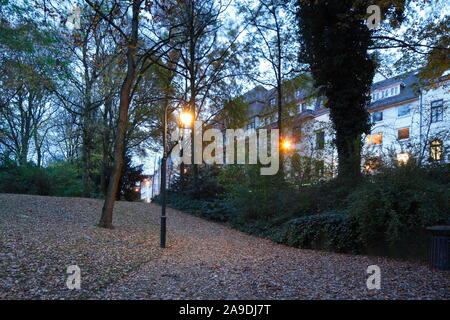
[{"left": 0, "top": 194, "right": 450, "bottom": 300}]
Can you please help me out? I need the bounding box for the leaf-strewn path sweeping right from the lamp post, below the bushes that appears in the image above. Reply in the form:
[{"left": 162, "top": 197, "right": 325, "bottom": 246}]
[{"left": 96, "top": 202, "right": 450, "bottom": 299}]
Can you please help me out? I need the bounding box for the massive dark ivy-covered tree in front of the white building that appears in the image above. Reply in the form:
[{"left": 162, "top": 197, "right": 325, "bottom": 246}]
[{"left": 297, "top": 0, "right": 375, "bottom": 180}]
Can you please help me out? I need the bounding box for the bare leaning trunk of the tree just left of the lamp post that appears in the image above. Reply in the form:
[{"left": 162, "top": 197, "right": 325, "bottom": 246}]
[{"left": 99, "top": 0, "right": 140, "bottom": 229}]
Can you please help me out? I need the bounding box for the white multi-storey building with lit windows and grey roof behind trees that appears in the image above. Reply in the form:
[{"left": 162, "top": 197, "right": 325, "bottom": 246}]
[{"left": 239, "top": 73, "right": 450, "bottom": 178}]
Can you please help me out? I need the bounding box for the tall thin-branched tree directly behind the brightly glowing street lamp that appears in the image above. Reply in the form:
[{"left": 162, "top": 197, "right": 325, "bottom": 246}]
[{"left": 153, "top": 0, "right": 246, "bottom": 194}]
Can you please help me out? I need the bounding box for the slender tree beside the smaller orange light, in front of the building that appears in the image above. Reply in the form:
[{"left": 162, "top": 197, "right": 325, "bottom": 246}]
[{"left": 240, "top": 0, "right": 302, "bottom": 175}]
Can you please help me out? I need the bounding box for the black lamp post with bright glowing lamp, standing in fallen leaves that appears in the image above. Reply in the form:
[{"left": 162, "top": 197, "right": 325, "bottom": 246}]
[{"left": 160, "top": 105, "right": 192, "bottom": 248}]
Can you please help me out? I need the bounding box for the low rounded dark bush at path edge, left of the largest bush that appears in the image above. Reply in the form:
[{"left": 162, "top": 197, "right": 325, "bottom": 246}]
[{"left": 282, "top": 213, "right": 361, "bottom": 253}]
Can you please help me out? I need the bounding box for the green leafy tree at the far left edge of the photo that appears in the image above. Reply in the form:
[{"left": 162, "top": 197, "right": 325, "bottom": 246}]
[{"left": 0, "top": 4, "right": 61, "bottom": 166}]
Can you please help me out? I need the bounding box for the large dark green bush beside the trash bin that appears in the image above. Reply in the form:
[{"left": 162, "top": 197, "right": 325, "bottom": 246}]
[{"left": 348, "top": 166, "right": 450, "bottom": 257}]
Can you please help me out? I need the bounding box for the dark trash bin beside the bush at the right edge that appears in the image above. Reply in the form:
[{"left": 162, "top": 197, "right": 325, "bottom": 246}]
[{"left": 427, "top": 226, "right": 450, "bottom": 271}]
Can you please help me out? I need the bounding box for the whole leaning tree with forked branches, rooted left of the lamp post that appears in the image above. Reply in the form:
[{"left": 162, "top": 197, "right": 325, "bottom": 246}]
[{"left": 81, "top": 0, "right": 181, "bottom": 228}]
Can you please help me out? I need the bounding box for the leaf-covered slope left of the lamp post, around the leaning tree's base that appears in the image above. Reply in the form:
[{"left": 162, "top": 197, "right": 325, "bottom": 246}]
[{"left": 0, "top": 194, "right": 161, "bottom": 299}]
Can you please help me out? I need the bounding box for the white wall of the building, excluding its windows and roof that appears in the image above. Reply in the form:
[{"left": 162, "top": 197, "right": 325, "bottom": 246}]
[{"left": 295, "top": 81, "right": 450, "bottom": 175}]
